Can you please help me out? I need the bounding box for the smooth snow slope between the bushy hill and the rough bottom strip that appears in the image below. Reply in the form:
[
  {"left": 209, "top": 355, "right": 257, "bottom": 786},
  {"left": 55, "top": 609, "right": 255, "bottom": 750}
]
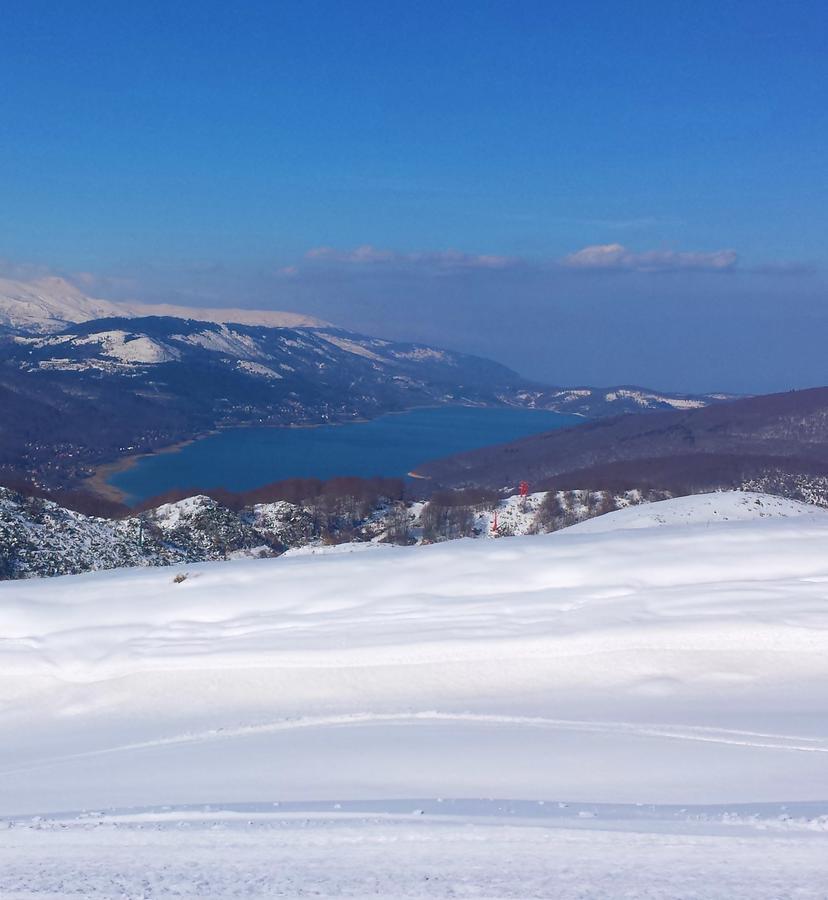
[{"left": 0, "top": 492, "right": 828, "bottom": 812}]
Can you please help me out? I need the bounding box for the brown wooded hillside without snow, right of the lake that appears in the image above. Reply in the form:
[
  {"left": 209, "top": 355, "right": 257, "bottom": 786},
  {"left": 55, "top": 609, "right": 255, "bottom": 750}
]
[{"left": 417, "top": 387, "right": 828, "bottom": 500}]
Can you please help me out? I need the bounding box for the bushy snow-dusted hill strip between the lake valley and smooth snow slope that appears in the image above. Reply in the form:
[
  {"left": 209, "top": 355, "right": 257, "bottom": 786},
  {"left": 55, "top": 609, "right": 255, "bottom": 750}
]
[{"left": 0, "top": 487, "right": 828, "bottom": 580}]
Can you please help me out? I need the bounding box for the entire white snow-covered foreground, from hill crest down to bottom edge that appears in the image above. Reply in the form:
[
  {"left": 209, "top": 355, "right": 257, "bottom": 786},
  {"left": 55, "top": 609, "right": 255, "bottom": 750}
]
[{"left": 0, "top": 495, "right": 828, "bottom": 898}]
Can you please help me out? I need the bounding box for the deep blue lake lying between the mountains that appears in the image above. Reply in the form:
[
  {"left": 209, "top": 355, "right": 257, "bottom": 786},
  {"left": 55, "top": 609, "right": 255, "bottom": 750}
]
[{"left": 109, "top": 406, "right": 584, "bottom": 502}]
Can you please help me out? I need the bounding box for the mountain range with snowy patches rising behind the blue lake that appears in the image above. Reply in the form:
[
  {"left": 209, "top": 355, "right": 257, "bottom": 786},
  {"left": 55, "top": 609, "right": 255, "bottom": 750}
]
[{"left": 0, "top": 281, "right": 728, "bottom": 500}]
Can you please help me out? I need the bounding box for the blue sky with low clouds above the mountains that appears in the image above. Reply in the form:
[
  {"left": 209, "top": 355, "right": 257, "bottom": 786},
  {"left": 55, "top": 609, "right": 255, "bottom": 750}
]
[{"left": 0, "top": 0, "right": 828, "bottom": 391}]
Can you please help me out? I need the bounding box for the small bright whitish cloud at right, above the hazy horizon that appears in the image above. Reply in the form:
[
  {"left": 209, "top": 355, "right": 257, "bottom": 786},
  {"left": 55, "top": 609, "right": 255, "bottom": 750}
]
[{"left": 561, "top": 244, "right": 738, "bottom": 272}]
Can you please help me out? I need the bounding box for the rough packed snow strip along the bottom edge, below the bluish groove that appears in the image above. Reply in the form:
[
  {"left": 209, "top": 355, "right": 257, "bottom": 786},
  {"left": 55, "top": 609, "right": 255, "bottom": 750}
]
[{"left": 0, "top": 812, "right": 828, "bottom": 900}]
